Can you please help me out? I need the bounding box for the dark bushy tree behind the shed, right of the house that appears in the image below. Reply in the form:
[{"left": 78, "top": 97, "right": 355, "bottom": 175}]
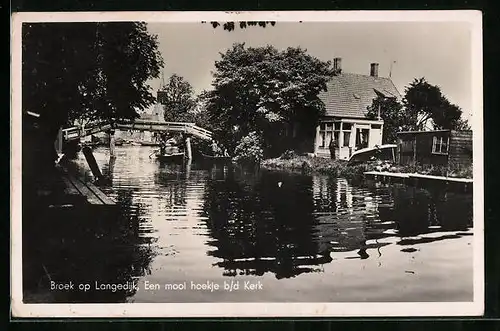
[{"left": 403, "top": 78, "right": 463, "bottom": 130}]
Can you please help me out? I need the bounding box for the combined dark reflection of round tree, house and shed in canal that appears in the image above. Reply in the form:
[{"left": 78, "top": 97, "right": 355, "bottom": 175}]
[{"left": 204, "top": 172, "right": 472, "bottom": 279}]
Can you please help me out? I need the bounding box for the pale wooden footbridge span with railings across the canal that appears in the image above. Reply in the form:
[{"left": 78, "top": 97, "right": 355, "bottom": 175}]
[{"left": 62, "top": 119, "right": 212, "bottom": 141}]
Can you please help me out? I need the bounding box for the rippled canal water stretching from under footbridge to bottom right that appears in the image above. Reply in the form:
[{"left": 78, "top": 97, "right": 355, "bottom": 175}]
[{"left": 30, "top": 146, "right": 473, "bottom": 303}]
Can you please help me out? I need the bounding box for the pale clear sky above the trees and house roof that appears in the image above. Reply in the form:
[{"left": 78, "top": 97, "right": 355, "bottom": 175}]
[{"left": 148, "top": 22, "right": 473, "bottom": 117}]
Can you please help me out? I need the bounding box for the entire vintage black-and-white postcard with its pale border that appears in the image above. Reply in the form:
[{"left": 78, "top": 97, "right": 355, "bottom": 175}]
[{"left": 11, "top": 11, "right": 484, "bottom": 318}]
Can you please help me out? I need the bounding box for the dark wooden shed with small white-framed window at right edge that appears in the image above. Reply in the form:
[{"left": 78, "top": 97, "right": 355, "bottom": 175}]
[{"left": 397, "top": 130, "right": 472, "bottom": 166}]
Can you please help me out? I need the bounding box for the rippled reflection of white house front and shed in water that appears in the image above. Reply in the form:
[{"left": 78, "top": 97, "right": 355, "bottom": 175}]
[{"left": 313, "top": 176, "right": 472, "bottom": 255}]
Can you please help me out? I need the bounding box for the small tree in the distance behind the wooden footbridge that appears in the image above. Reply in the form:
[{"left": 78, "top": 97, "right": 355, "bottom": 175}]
[{"left": 158, "top": 74, "right": 196, "bottom": 122}]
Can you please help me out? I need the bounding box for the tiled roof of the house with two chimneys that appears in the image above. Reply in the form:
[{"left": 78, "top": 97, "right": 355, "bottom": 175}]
[{"left": 319, "top": 73, "right": 401, "bottom": 118}]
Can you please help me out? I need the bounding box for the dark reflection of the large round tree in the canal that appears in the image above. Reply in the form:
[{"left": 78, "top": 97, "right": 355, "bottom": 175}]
[{"left": 204, "top": 172, "right": 331, "bottom": 278}]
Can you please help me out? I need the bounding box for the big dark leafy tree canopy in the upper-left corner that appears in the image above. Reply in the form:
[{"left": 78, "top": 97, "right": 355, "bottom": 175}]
[{"left": 22, "top": 22, "right": 163, "bottom": 131}]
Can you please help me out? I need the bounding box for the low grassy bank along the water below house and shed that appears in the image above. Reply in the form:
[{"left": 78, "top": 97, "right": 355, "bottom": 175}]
[{"left": 261, "top": 155, "right": 472, "bottom": 179}]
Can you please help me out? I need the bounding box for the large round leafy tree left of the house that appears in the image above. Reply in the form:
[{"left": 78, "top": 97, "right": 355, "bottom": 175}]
[{"left": 201, "top": 43, "right": 333, "bottom": 154}]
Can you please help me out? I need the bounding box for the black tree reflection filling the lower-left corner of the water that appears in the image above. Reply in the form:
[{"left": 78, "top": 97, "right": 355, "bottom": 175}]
[{"left": 23, "top": 190, "right": 155, "bottom": 303}]
